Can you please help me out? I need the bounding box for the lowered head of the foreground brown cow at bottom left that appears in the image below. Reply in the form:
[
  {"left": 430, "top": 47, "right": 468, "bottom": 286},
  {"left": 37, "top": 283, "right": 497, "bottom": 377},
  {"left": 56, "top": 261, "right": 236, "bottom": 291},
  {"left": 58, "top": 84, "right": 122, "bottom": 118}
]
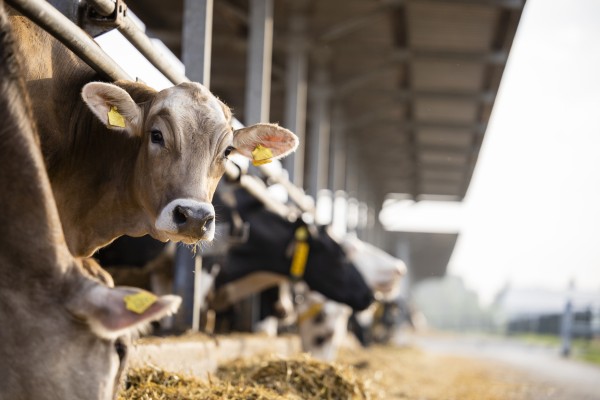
[{"left": 0, "top": 264, "right": 180, "bottom": 400}]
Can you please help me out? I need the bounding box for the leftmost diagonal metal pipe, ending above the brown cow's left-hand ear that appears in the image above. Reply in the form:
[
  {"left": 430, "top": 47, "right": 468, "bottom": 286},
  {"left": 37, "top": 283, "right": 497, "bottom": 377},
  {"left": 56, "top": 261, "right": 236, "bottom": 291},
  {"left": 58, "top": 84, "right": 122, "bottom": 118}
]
[{"left": 6, "top": 0, "right": 132, "bottom": 81}]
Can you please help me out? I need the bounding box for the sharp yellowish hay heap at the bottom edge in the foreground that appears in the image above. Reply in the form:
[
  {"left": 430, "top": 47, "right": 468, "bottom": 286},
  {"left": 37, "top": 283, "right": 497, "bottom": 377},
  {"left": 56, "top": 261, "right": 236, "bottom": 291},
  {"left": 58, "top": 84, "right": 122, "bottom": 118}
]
[{"left": 118, "top": 357, "right": 371, "bottom": 400}]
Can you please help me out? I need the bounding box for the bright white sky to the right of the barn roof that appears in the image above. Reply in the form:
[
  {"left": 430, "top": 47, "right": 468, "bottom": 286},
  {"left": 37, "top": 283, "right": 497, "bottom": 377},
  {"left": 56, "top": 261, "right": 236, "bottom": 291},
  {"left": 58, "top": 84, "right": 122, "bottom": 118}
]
[{"left": 382, "top": 0, "right": 600, "bottom": 303}]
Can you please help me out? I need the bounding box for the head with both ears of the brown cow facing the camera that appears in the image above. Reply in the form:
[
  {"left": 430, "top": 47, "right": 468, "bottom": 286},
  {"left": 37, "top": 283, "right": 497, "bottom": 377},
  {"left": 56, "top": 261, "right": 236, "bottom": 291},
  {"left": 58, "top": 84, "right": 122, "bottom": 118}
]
[{"left": 82, "top": 82, "right": 298, "bottom": 244}]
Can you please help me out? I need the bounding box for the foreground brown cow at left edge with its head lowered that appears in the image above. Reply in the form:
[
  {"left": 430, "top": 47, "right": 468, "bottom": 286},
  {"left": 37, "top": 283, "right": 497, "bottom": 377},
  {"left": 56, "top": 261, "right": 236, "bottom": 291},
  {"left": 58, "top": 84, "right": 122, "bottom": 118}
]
[{"left": 0, "top": 0, "right": 180, "bottom": 400}]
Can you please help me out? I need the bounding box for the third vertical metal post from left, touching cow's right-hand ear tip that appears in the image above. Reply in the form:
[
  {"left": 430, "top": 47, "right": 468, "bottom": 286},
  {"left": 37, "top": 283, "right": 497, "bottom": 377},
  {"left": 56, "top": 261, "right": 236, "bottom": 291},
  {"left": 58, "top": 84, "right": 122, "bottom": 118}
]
[{"left": 283, "top": 7, "right": 308, "bottom": 187}]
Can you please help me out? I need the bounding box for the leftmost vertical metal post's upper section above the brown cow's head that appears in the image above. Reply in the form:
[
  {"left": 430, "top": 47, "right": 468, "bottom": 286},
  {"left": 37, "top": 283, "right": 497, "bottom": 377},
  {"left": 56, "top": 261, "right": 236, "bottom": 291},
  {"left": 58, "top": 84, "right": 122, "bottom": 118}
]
[{"left": 182, "top": 0, "right": 213, "bottom": 87}]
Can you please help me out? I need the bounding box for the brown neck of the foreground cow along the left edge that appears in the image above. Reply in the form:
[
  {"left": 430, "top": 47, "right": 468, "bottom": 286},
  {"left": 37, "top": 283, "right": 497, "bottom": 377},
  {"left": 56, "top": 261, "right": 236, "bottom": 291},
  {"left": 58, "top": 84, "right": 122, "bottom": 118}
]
[{"left": 0, "top": 13, "right": 73, "bottom": 292}]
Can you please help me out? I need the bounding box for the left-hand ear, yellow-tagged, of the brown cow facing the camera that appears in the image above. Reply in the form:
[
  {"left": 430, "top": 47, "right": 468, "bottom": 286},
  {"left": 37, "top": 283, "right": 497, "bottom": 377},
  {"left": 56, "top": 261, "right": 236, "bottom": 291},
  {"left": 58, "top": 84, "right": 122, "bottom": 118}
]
[{"left": 81, "top": 82, "right": 142, "bottom": 135}]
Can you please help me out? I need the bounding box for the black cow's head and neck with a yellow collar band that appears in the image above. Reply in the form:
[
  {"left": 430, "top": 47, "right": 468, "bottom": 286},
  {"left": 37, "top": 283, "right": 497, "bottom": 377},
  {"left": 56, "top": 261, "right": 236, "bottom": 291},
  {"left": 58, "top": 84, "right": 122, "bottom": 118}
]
[{"left": 209, "top": 189, "right": 373, "bottom": 310}]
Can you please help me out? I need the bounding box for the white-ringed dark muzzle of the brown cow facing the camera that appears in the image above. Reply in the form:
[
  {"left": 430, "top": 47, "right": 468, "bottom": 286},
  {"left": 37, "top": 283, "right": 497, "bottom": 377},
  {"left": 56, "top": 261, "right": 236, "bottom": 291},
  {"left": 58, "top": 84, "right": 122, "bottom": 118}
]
[{"left": 156, "top": 199, "right": 215, "bottom": 244}]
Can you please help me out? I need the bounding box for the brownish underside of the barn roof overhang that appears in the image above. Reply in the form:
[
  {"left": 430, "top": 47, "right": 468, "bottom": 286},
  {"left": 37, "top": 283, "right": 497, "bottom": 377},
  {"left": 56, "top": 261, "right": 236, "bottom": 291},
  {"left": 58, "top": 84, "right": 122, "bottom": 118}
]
[{"left": 128, "top": 0, "right": 524, "bottom": 200}]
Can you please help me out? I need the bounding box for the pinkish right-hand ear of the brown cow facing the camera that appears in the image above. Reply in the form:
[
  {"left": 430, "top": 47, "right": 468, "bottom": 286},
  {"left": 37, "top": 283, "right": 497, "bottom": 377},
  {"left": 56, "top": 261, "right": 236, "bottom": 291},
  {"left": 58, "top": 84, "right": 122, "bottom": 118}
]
[{"left": 233, "top": 124, "right": 298, "bottom": 161}]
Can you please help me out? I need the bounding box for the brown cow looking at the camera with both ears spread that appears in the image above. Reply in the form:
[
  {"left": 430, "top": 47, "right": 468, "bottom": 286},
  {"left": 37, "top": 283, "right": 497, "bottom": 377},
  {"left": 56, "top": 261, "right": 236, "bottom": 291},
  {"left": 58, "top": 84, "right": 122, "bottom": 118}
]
[{"left": 12, "top": 12, "right": 298, "bottom": 256}]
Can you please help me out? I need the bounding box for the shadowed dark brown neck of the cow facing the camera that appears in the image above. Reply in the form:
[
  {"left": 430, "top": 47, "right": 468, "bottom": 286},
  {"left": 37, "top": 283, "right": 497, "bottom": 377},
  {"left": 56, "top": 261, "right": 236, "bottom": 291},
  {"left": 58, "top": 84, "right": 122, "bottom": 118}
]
[{"left": 49, "top": 98, "right": 147, "bottom": 256}]
